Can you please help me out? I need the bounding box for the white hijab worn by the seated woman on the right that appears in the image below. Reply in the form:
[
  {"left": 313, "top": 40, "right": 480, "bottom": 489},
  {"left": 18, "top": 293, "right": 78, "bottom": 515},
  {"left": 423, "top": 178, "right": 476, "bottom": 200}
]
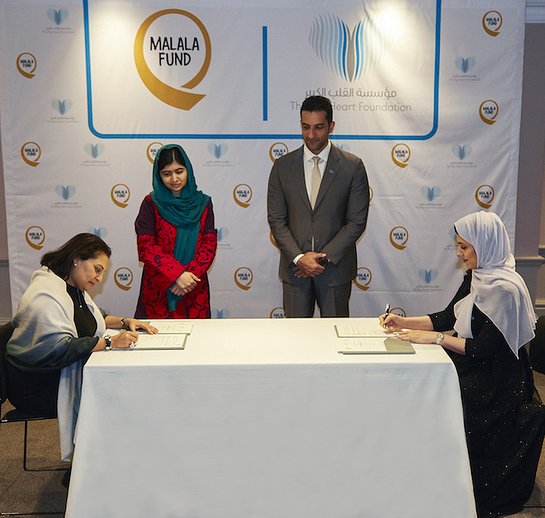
[{"left": 454, "top": 211, "right": 536, "bottom": 358}]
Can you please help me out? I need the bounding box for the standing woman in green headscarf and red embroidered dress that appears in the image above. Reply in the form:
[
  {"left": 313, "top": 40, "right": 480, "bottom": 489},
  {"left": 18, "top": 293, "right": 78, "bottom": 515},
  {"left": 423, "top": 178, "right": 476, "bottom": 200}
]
[{"left": 135, "top": 144, "right": 217, "bottom": 318}]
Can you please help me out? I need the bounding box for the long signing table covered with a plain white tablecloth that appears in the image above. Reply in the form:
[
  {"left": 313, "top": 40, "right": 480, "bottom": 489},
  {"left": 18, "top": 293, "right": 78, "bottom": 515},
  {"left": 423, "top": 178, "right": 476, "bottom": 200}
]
[{"left": 66, "top": 318, "right": 475, "bottom": 518}]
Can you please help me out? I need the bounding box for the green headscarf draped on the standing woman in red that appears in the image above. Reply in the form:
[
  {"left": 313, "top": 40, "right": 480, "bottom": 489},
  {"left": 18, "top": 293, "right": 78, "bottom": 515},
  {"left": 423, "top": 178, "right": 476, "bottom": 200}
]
[{"left": 151, "top": 144, "right": 210, "bottom": 311}]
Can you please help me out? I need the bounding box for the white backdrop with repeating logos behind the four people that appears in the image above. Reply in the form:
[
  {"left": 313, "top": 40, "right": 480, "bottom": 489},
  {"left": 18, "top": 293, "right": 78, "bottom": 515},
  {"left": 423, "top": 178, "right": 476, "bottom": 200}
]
[{"left": 0, "top": 0, "right": 525, "bottom": 318}]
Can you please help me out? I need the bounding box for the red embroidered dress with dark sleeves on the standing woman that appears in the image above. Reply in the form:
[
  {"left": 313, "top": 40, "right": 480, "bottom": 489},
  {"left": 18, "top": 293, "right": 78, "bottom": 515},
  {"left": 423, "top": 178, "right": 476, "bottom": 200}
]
[{"left": 134, "top": 195, "right": 217, "bottom": 318}]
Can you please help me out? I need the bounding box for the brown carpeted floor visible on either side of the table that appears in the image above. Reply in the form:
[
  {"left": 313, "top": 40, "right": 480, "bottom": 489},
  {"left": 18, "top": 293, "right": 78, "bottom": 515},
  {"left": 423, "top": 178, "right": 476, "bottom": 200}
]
[{"left": 0, "top": 374, "right": 545, "bottom": 518}]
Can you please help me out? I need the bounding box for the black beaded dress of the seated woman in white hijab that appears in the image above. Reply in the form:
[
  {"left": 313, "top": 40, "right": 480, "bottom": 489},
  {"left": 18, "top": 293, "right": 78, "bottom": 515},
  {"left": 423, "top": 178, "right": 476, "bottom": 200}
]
[{"left": 429, "top": 270, "right": 545, "bottom": 518}]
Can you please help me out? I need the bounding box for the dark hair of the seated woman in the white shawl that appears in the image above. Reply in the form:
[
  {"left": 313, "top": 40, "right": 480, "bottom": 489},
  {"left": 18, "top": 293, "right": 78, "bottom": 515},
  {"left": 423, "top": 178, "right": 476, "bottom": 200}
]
[{"left": 40, "top": 232, "right": 112, "bottom": 280}]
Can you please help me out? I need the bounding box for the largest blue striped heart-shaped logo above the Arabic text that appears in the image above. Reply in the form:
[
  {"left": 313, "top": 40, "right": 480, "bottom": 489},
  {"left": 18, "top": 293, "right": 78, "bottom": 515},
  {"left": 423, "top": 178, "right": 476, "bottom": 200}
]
[{"left": 309, "top": 15, "right": 367, "bottom": 81}]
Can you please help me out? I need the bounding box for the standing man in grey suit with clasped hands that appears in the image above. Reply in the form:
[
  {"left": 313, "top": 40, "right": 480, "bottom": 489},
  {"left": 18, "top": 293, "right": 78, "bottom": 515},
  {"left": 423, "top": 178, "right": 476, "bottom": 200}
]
[{"left": 267, "top": 96, "right": 369, "bottom": 317}]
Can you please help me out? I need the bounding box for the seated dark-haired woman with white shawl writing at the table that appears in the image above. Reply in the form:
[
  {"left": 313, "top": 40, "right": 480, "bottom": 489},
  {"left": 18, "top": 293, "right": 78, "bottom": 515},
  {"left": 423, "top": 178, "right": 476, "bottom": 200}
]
[{"left": 6, "top": 233, "right": 155, "bottom": 468}]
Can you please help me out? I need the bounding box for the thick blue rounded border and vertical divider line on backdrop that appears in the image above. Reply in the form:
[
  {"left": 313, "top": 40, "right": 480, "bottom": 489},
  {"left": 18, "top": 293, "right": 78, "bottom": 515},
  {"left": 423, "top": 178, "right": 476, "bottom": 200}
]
[{"left": 82, "top": 0, "right": 442, "bottom": 140}]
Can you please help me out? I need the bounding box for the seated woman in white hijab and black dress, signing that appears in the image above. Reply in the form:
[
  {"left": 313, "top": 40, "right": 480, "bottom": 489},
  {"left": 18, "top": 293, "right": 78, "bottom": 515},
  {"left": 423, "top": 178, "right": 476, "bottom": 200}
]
[{"left": 379, "top": 212, "right": 545, "bottom": 518}]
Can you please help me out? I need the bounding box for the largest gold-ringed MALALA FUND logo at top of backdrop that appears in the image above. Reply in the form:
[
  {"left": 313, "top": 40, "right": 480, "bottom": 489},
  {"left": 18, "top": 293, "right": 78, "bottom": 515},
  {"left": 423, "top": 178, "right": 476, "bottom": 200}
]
[{"left": 134, "top": 9, "right": 212, "bottom": 110}]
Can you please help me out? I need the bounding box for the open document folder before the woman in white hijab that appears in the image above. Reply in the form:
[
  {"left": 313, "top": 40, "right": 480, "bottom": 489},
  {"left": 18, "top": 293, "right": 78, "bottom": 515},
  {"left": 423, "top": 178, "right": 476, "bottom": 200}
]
[{"left": 335, "top": 323, "right": 415, "bottom": 354}]
